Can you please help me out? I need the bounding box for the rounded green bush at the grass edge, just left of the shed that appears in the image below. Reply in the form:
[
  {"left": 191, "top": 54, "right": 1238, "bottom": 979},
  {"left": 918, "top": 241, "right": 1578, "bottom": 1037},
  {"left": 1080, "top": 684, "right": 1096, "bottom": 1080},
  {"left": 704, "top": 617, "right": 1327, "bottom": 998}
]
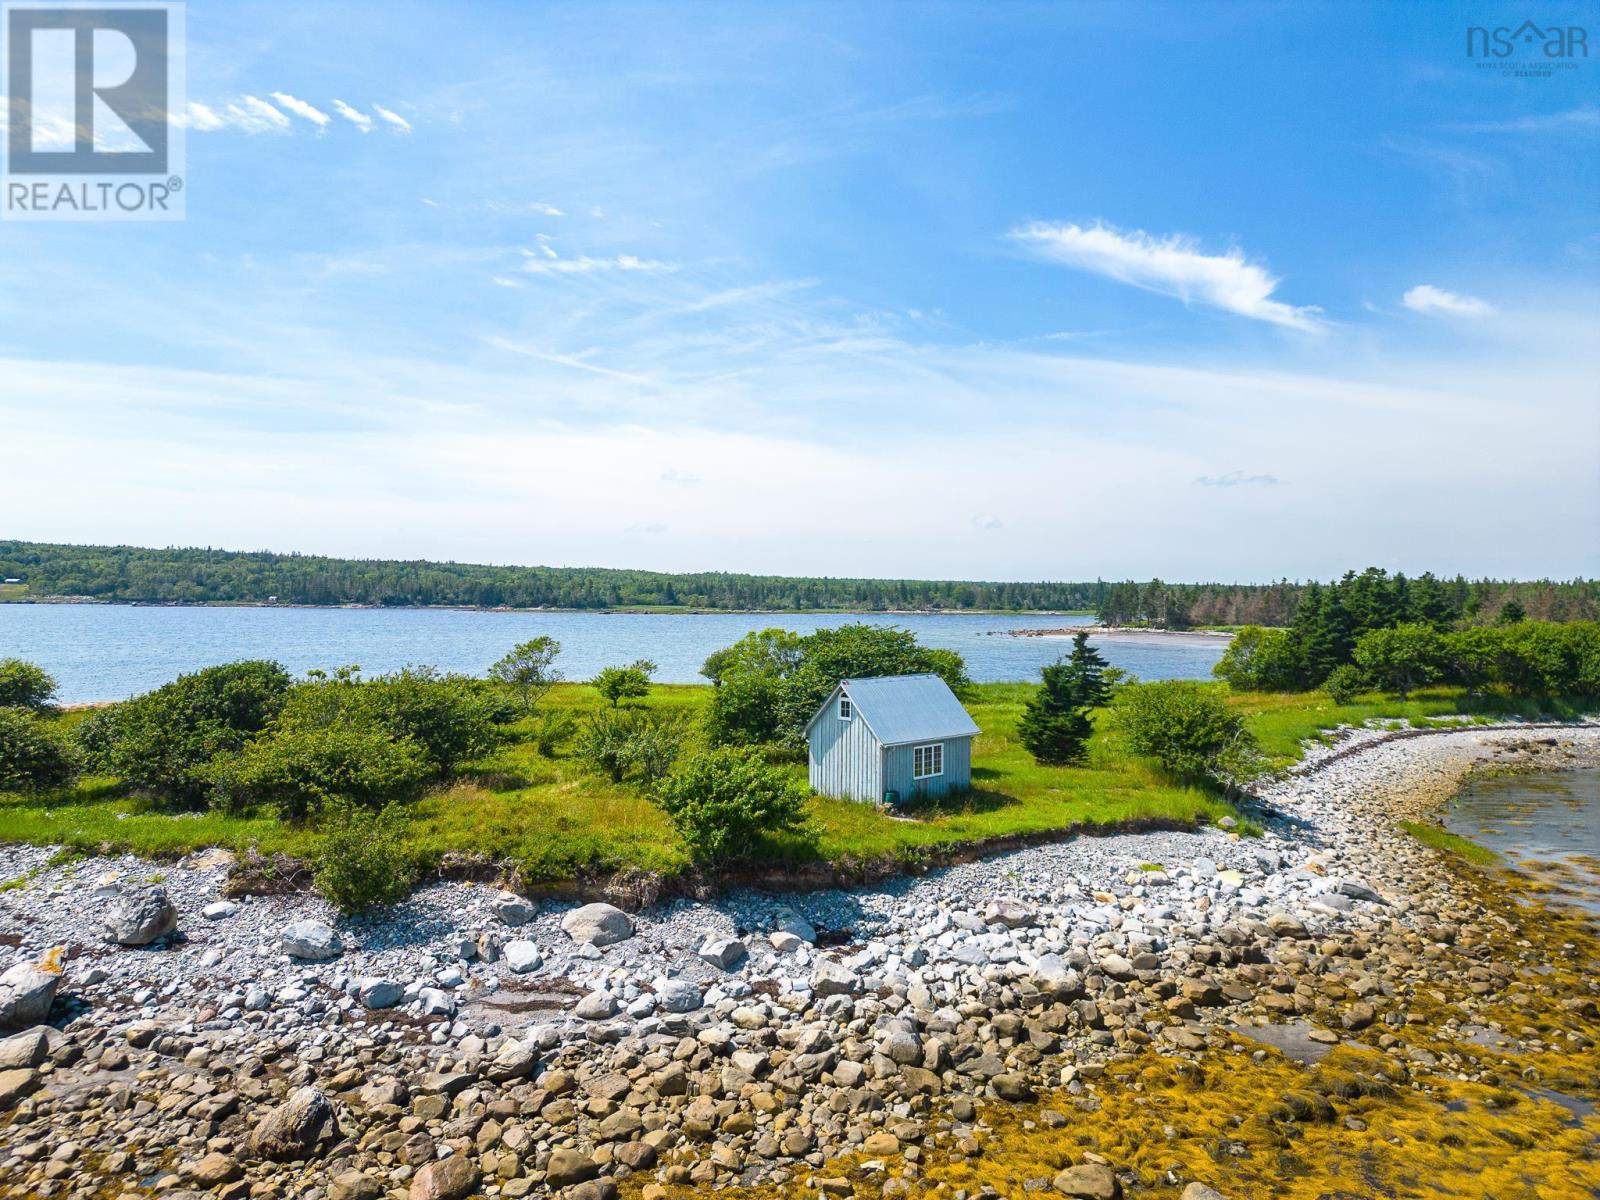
[{"left": 656, "top": 747, "right": 806, "bottom": 867}]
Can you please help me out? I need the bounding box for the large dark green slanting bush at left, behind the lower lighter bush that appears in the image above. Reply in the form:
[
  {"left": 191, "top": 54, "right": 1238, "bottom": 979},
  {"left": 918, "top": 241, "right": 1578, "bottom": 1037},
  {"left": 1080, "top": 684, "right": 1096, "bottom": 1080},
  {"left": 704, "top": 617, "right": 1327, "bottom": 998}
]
[{"left": 91, "top": 661, "right": 290, "bottom": 805}]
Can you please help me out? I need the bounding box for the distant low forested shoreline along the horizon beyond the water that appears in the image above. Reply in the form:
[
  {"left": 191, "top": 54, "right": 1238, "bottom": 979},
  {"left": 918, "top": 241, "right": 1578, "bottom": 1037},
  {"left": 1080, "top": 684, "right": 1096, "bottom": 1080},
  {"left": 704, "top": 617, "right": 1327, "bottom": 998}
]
[{"left": 0, "top": 539, "right": 1600, "bottom": 629}]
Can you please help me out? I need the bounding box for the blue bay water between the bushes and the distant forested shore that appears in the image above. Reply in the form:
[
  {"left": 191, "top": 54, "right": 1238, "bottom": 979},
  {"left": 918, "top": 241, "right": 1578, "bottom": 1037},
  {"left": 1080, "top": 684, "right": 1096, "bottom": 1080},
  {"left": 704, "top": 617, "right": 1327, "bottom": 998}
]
[{"left": 0, "top": 605, "right": 1222, "bottom": 704}]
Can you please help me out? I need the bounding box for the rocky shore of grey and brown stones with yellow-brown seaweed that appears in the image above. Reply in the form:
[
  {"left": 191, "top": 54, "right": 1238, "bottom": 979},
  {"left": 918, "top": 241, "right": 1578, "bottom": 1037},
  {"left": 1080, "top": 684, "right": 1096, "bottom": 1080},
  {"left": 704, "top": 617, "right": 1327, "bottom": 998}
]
[{"left": 0, "top": 725, "right": 1600, "bottom": 1200}]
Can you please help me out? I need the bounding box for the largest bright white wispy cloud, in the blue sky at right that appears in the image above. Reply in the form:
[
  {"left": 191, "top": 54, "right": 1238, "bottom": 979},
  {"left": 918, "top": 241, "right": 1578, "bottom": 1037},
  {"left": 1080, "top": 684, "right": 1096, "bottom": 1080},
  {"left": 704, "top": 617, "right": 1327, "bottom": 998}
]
[{"left": 1011, "top": 221, "right": 1322, "bottom": 330}]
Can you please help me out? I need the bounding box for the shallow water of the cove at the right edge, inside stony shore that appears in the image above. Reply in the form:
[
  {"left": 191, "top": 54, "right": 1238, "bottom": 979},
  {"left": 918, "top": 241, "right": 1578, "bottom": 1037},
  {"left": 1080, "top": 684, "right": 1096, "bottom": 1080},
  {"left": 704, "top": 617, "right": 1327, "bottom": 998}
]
[{"left": 1445, "top": 770, "right": 1600, "bottom": 912}]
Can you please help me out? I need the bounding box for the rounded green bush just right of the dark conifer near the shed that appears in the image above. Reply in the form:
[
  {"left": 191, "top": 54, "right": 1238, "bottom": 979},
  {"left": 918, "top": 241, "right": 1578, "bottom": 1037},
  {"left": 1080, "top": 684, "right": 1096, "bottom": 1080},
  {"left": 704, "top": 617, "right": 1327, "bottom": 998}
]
[{"left": 1117, "top": 680, "right": 1256, "bottom": 787}]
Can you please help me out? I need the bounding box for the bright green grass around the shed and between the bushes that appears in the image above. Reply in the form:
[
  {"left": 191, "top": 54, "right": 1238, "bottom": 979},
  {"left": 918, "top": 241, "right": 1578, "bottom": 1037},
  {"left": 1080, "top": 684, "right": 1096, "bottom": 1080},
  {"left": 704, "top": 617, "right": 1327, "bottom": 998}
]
[{"left": 0, "top": 683, "right": 1574, "bottom": 882}]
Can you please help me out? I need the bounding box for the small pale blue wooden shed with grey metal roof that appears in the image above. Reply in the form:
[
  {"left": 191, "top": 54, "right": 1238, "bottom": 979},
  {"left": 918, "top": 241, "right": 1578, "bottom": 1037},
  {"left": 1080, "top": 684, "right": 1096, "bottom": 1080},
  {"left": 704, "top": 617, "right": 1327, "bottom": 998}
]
[{"left": 806, "top": 675, "right": 978, "bottom": 803}]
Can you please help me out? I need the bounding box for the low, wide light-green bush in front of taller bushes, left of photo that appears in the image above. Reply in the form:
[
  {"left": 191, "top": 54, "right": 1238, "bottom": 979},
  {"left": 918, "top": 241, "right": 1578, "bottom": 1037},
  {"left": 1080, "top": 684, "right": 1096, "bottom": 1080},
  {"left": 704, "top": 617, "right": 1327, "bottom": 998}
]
[{"left": 211, "top": 723, "right": 432, "bottom": 821}]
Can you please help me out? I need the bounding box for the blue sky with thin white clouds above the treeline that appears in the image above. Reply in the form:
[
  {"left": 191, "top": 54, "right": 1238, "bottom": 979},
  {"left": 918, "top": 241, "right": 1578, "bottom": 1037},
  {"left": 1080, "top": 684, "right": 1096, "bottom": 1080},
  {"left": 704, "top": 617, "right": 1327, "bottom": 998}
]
[{"left": 0, "top": 0, "right": 1600, "bottom": 581}]
